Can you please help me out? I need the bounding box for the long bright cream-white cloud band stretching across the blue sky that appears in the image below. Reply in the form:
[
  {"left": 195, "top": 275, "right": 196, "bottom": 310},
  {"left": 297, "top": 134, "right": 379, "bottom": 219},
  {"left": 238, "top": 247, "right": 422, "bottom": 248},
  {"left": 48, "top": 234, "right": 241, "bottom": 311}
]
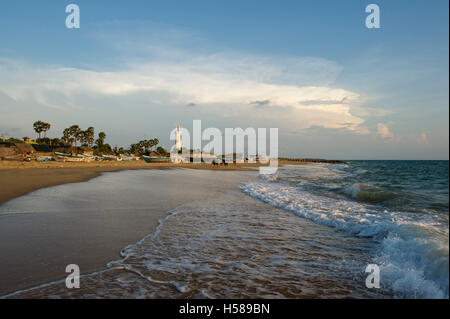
[{"left": 0, "top": 53, "right": 370, "bottom": 132}]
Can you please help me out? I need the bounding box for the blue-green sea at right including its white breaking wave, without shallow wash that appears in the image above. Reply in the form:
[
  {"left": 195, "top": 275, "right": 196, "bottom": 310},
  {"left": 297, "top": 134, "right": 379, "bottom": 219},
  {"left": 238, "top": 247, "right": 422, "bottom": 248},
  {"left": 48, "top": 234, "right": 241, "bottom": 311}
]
[{"left": 242, "top": 161, "right": 449, "bottom": 298}]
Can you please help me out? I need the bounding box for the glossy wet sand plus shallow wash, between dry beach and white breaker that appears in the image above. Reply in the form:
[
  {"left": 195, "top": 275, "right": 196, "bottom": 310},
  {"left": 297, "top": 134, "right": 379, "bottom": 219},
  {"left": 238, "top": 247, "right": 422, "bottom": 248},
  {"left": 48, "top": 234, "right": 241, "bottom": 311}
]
[{"left": 0, "top": 168, "right": 384, "bottom": 298}]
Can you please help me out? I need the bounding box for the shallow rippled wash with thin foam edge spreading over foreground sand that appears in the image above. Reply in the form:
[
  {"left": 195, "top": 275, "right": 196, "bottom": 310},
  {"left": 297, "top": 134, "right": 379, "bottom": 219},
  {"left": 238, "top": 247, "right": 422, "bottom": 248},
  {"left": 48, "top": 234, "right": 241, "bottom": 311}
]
[{"left": 4, "top": 190, "right": 389, "bottom": 299}]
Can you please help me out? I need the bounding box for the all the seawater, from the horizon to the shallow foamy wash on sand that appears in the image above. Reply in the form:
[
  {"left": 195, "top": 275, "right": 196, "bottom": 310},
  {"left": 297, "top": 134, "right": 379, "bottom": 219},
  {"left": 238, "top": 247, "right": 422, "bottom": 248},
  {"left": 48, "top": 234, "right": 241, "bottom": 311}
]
[{"left": 1, "top": 161, "right": 449, "bottom": 298}]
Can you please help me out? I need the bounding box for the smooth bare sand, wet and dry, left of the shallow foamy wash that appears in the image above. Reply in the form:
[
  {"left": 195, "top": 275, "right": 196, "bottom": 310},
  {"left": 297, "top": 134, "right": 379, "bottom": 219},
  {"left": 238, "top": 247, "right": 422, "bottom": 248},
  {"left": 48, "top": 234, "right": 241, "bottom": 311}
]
[{"left": 0, "top": 169, "right": 256, "bottom": 295}]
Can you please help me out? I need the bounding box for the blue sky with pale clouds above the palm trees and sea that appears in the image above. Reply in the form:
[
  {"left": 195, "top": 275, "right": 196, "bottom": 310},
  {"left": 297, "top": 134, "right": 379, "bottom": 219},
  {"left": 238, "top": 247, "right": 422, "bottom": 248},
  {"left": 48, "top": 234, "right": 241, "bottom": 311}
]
[{"left": 0, "top": 0, "right": 449, "bottom": 159}]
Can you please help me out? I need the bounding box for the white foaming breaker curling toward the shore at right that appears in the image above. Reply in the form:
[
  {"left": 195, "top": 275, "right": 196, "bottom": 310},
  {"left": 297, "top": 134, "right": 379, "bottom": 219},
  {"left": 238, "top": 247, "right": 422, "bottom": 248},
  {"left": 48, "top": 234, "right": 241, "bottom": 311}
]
[{"left": 241, "top": 181, "right": 449, "bottom": 298}]
